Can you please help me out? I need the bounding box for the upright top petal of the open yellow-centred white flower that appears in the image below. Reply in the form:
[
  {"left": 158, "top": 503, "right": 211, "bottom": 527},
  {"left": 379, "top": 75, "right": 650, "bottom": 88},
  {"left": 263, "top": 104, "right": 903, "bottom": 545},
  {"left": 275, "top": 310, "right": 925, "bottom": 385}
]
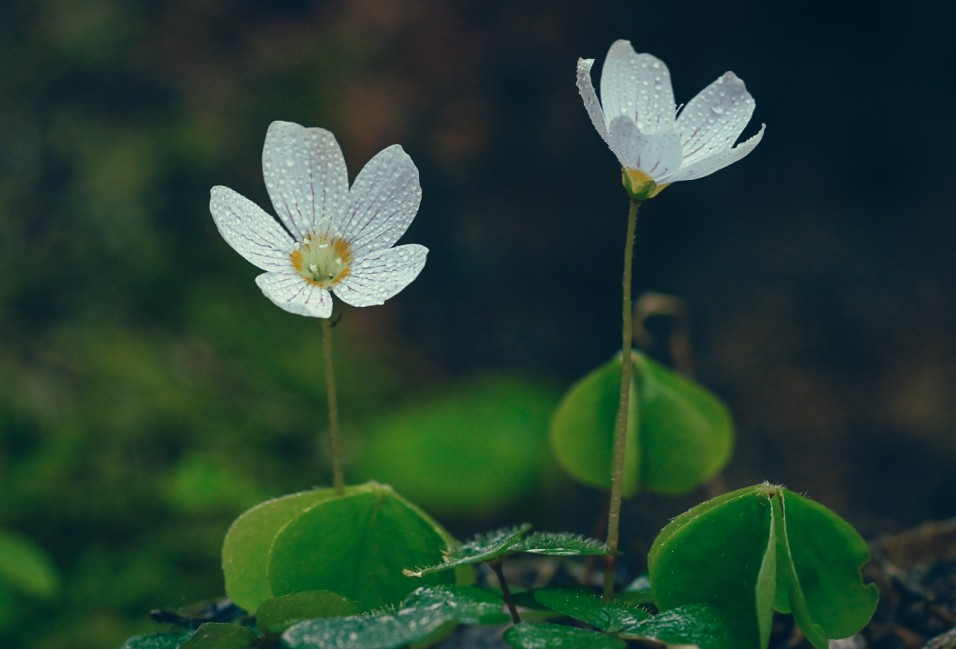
[{"left": 262, "top": 122, "right": 349, "bottom": 240}]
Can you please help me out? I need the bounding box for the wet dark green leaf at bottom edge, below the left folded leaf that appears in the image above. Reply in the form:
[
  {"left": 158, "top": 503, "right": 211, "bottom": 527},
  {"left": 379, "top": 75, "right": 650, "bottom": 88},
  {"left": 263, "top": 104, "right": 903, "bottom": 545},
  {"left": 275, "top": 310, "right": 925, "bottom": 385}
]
[{"left": 282, "top": 586, "right": 508, "bottom": 649}]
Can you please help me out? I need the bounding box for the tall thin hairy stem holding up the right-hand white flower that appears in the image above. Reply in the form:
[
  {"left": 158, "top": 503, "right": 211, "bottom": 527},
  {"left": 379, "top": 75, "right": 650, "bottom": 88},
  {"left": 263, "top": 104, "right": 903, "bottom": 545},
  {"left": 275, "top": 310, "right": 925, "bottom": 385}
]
[{"left": 604, "top": 200, "right": 640, "bottom": 600}]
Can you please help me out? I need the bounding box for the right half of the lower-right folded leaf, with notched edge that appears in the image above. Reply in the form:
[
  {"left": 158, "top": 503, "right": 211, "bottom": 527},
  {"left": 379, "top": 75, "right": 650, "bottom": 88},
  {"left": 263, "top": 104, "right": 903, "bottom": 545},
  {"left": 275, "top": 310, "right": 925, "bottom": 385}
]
[{"left": 774, "top": 489, "right": 879, "bottom": 649}]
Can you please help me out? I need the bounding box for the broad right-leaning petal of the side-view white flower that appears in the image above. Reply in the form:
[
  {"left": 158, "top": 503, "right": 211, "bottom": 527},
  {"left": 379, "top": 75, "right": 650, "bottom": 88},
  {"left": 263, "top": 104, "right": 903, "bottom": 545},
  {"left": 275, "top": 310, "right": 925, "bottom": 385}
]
[{"left": 677, "top": 72, "right": 757, "bottom": 166}]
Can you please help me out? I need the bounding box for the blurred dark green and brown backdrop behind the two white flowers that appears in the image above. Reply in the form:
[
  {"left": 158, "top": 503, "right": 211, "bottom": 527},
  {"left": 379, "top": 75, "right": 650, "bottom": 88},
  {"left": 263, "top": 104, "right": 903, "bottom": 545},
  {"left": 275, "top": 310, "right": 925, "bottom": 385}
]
[{"left": 0, "top": 0, "right": 956, "bottom": 649}]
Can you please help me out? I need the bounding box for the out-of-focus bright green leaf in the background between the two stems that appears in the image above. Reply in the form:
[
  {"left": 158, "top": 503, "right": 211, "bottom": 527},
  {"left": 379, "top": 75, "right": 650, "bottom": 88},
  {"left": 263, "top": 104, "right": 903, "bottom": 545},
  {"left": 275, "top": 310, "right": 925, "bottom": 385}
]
[{"left": 351, "top": 376, "right": 559, "bottom": 516}]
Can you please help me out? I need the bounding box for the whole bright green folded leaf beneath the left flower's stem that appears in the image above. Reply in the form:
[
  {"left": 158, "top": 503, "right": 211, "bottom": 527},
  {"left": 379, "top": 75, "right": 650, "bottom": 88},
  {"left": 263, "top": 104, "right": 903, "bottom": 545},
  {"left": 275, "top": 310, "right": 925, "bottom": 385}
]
[{"left": 223, "top": 483, "right": 464, "bottom": 610}]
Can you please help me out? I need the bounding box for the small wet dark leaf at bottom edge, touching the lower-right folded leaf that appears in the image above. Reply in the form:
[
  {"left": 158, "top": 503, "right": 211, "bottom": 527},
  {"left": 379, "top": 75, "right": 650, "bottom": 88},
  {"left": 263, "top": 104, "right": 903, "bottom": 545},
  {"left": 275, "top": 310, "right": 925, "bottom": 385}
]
[{"left": 621, "top": 604, "right": 739, "bottom": 649}]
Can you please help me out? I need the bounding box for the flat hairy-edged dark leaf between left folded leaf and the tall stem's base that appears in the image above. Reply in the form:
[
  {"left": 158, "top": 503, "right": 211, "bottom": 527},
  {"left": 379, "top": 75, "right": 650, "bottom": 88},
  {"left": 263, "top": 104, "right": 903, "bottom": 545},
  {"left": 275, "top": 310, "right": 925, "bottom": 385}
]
[{"left": 404, "top": 523, "right": 608, "bottom": 577}]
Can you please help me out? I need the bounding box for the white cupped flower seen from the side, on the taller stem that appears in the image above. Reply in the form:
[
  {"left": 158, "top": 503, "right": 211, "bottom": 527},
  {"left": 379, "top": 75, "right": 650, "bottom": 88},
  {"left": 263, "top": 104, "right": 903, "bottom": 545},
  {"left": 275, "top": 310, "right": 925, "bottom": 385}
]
[{"left": 578, "top": 40, "right": 765, "bottom": 201}]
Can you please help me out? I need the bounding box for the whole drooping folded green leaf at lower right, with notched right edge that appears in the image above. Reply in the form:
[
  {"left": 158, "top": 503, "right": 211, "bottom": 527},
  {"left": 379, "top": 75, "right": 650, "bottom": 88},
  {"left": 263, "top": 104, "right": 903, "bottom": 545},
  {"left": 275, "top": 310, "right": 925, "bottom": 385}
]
[{"left": 648, "top": 484, "right": 877, "bottom": 649}]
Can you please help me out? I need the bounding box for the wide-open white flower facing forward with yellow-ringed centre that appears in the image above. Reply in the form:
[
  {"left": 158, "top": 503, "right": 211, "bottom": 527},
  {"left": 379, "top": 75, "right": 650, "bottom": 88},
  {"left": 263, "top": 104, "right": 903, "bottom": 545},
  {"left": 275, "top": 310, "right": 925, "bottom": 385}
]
[{"left": 215, "top": 122, "right": 428, "bottom": 318}]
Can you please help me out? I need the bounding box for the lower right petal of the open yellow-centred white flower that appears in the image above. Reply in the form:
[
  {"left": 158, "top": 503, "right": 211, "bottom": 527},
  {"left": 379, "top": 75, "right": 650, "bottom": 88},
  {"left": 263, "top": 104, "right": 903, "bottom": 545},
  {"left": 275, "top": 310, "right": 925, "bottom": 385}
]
[{"left": 332, "top": 243, "right": 428, "bottom": 306}]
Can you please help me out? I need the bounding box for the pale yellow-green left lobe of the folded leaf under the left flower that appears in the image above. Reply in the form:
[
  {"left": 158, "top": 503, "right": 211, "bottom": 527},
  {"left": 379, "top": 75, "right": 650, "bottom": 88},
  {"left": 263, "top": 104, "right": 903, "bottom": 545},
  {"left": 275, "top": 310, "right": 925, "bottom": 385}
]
[{"left": 222, "top": 489, "right": 335, "bottom": 611}]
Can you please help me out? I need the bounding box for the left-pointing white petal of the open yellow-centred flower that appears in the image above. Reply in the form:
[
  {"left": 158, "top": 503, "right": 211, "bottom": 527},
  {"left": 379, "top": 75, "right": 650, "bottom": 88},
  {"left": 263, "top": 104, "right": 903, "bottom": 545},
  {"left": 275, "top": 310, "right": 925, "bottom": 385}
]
[{"left": 209, "top": 185, "right": 294, "bottom": 270}]
